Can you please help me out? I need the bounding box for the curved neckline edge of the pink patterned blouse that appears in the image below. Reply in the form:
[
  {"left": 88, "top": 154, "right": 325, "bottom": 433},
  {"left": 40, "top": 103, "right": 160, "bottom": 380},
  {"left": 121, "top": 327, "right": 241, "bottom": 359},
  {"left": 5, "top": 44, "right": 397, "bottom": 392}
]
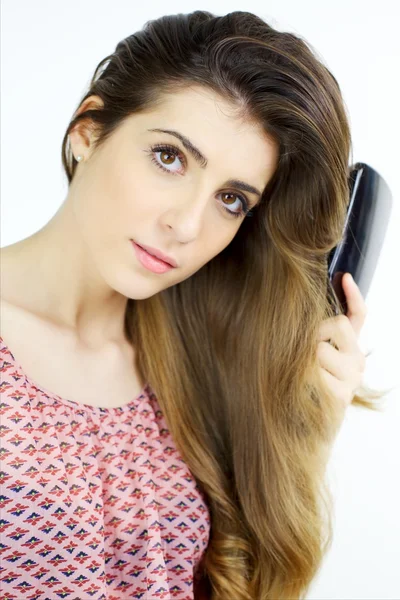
[{"left": 0, "top": 335, "right": 149, "bottom": 414}]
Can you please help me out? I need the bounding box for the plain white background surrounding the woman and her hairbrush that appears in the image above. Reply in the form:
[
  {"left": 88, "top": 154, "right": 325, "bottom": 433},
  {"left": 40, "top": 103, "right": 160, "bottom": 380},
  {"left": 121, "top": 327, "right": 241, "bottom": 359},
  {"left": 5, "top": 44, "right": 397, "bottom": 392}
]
[{"left": 1, "top": 0, "right": 400, "bottom": 600}]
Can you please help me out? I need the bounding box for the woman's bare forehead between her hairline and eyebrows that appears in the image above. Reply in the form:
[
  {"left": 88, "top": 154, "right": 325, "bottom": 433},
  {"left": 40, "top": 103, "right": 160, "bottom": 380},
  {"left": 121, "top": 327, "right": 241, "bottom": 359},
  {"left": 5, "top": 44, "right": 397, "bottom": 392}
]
[{"left": 133, "top": 86, "right": 278, "bottom": 188}]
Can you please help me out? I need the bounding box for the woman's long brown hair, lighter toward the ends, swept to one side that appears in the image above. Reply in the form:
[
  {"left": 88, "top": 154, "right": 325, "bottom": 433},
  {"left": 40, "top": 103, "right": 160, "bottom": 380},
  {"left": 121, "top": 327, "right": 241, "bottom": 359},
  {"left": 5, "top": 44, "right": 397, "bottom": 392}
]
[{"left": 62, "top": 10, "right": 390, "bottom": 600}]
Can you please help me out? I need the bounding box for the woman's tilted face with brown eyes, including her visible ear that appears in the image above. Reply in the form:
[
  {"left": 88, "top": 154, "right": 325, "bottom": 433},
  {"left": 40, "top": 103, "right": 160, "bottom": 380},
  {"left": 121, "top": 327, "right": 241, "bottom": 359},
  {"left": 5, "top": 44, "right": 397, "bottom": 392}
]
[{"left": 70, "top": 87, "right": 278, "bottom": 299}]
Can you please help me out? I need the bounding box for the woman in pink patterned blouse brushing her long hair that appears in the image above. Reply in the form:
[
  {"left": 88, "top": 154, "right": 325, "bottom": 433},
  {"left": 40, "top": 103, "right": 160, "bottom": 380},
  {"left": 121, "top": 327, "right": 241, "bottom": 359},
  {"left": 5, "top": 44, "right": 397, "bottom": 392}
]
[{"left": 0, "top": 10, "right": 383, "bottom": 600}]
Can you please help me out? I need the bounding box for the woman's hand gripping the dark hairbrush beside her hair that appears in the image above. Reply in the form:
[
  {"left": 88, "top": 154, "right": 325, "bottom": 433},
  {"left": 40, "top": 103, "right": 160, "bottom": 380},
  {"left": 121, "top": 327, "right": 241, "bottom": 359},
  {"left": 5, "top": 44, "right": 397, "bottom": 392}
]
[{"left": 317, "top": 273, "right": 367, "bottom": 408}]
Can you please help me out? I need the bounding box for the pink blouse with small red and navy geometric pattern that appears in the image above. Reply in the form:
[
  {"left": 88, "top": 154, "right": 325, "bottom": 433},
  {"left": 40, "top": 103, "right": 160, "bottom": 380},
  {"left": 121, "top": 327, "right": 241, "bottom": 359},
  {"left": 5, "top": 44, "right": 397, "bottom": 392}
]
[{"left": 0, "top": 337, "right": 210, "bottom": 600}]
